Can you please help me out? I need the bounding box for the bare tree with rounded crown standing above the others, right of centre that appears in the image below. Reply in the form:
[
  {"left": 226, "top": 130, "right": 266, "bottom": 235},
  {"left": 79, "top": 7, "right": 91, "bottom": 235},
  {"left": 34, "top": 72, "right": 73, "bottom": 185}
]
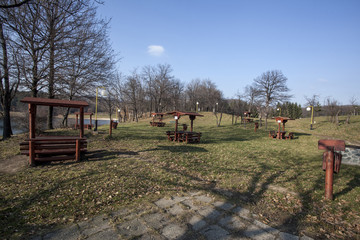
[{"left": 253, "top": 70, "right": 291, "bottom": 129}]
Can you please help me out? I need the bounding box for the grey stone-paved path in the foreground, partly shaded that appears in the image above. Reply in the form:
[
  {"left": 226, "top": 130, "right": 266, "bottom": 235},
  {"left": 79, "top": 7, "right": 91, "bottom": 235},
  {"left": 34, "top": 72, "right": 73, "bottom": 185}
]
[{"left": 32, "top": 192, "right": 311, "bottom": 240}]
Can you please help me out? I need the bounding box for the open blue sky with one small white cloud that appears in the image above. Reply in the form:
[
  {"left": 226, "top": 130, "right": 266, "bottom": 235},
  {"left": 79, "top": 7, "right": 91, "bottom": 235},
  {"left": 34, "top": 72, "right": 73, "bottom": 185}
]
[{"left": 98, "top": 0, "right": 360, "bottom": 105}]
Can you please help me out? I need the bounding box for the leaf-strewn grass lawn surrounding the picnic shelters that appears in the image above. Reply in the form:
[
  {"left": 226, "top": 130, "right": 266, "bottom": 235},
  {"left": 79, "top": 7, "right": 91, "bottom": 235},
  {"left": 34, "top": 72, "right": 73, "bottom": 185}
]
[{"left": 0, "top": 113, "right": 360, "bottom": 239}]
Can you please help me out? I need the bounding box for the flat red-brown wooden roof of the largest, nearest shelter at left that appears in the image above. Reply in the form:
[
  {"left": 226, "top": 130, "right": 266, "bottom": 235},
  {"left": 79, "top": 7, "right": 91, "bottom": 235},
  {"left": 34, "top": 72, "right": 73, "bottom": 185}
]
[{"left": 20, "top": 97, "right": 89, "bottom": 108}]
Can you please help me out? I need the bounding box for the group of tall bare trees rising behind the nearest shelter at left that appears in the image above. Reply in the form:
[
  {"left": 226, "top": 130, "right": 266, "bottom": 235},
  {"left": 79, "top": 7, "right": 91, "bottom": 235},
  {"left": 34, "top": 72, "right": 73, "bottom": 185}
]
[{"left": 0, "top": 0, "right": 116, "bottom": 138}]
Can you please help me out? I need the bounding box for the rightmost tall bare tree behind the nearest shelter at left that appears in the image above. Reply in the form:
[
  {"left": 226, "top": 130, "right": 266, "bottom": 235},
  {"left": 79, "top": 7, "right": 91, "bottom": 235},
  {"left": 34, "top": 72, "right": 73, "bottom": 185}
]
[{"left": 55, "top": 2, "right": 116, "bottom": 124}]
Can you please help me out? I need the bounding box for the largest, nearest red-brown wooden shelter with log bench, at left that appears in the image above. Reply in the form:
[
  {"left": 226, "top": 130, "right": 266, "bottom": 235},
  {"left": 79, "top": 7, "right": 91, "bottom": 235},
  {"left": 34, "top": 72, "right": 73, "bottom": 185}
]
[{"left": 20, "top": 97, "right": 89, "bottom": 166}]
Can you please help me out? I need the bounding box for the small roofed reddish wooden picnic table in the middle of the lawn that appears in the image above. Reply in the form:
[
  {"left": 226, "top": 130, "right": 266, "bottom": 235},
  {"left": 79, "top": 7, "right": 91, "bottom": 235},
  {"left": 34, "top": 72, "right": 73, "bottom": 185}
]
[{"left": 166, "top": 111, "right": 203, "bottom": 143}]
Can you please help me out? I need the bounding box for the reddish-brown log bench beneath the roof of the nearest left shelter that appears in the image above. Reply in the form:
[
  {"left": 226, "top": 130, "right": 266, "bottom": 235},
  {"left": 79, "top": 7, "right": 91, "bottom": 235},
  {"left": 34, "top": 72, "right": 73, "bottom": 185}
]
[{"left": 20, "top": 136, "right": 87, "bottom": 162}]
